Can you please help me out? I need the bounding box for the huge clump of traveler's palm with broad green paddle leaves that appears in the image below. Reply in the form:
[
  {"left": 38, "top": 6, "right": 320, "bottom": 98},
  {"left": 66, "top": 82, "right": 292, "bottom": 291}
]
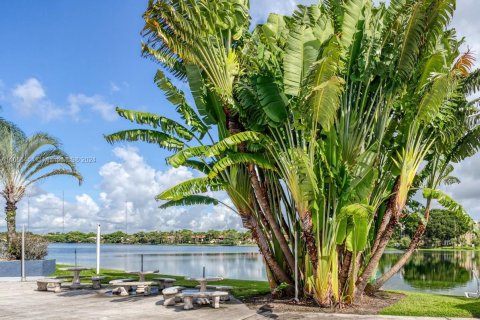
[{"left": 107, "top": 0, "right": 480, "bottom": 305}]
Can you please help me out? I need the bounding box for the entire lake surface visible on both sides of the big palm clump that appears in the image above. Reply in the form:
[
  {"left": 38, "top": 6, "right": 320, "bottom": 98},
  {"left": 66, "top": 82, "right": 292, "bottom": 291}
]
[{"left": 48, "top": 243, "right": 480, "bottom": 295}]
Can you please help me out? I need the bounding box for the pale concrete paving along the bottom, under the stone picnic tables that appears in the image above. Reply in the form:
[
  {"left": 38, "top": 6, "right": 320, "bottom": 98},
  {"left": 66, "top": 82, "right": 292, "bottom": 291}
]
[{"left": 0, "top": 282, "right": 472, "bottom": 320}]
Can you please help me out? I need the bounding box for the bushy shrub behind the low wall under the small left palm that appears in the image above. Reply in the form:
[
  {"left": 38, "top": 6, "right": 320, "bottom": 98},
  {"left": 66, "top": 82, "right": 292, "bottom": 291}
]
[{"left": 8, "top": 234, "right": 48, "bottom": 260}]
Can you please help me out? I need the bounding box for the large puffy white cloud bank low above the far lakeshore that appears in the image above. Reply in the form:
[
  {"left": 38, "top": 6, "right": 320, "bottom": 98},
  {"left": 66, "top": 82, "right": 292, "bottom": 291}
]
[{"left": 0, "top": 147, "right": 242, "bottom": 233}]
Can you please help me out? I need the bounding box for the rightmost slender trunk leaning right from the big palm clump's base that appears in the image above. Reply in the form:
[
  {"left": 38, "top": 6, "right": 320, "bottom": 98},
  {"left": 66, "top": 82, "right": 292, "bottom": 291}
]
[{"left": 366, "top": 205, "right": 431, "bottom": 292}]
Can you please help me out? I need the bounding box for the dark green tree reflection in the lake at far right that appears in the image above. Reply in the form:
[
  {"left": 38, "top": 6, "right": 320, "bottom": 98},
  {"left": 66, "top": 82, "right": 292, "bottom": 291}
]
[{"left": 402, "top": 252, "right": 472, "bottom": 290}]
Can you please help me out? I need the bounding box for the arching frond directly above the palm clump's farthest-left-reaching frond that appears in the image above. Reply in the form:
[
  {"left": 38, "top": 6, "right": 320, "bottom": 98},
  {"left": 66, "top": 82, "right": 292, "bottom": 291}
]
[{"left": 116, "top": 107, "right": 194, "bottom": 141}]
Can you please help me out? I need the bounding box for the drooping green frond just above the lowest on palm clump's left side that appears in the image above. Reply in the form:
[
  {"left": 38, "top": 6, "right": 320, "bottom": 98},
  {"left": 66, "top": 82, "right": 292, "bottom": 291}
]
[{"left": 156, "top": 177, "right": 224, "bottom": 201}]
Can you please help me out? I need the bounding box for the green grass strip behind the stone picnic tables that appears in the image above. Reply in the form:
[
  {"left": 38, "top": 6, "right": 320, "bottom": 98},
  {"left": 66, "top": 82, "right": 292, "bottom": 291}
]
[{"left": 53, "top": 264, "right": 270, "bottom": 299}]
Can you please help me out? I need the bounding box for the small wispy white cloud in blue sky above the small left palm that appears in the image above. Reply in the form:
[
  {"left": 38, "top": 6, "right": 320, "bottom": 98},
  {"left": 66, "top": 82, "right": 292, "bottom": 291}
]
[{"left": 8, "top": 78, "right": 117, "bottom": 122}]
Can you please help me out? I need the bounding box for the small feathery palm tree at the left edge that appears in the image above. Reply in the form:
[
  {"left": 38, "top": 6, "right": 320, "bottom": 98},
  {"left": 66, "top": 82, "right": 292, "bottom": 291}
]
[{"left": 0, "top": 119, "right": 83, "bottom": 249}]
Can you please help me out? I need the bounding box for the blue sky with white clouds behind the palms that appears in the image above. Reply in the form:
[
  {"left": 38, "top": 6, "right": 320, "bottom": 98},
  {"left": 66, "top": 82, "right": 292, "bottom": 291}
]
[{"left": 0, "top": 0, "right": 480, "bottom": 232}]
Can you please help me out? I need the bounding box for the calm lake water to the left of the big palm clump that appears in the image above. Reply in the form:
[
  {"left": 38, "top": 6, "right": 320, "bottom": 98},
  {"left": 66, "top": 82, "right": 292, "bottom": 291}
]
[{"left": 48, "top": 243, "right": 267, "bottom": 280}]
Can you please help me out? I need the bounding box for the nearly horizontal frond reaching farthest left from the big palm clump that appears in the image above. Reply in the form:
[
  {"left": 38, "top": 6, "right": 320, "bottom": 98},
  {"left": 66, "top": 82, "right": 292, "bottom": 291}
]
[{"left": 105, "top": 129, "right": 185, "bottom": 150}]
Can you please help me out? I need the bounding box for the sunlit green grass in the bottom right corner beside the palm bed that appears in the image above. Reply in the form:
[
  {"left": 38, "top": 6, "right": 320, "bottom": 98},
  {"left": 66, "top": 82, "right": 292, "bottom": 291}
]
[{"left": 380, "top": 291, "right": 480, "bottom": 318}]
